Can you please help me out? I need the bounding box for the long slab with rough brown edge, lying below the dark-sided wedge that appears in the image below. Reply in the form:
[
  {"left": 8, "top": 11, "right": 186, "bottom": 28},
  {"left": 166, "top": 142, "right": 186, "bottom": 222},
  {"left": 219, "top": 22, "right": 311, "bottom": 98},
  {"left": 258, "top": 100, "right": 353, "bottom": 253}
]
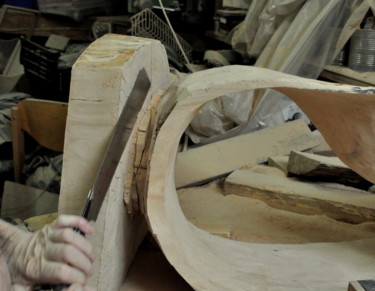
[{"left": 225, "top": 166, "right": 375, "bottom": 223}]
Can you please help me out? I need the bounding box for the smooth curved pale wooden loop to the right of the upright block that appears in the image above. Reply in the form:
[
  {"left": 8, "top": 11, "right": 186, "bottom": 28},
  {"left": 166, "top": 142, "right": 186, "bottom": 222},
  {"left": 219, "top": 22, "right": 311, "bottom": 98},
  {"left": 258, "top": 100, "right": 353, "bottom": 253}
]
[{"left": 147, "top": 66, "right": 375, "bottom": 291}]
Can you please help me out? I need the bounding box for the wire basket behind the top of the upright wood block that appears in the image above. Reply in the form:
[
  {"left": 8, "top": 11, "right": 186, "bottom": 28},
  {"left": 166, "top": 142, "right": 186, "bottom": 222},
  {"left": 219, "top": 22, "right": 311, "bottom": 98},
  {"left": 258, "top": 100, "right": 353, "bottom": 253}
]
[{"left": 130, "top": 9, "right": 192, "bottom": 64}]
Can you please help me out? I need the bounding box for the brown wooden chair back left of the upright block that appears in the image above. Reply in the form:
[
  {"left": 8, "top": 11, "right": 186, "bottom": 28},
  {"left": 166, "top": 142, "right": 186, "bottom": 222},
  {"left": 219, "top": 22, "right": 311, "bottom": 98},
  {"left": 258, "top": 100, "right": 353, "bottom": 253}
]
[{"left": 11, "top": 99, "right": 68, "bottom": 183}]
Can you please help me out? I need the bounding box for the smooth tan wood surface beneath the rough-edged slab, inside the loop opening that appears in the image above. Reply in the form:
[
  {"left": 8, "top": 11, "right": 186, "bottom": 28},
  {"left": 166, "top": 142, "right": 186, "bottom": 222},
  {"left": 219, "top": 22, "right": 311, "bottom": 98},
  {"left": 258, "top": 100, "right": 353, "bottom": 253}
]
[{"left": 177, "top": 182, "right": 375, "bottom": 244}]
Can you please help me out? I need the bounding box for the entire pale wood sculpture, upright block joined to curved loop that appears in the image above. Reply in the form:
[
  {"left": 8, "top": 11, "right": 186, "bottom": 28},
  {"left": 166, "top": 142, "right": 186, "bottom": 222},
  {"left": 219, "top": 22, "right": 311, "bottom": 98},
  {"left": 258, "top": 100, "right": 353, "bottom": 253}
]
[{"left": 59, "top": 34, "right": 375, "bottom": 290}]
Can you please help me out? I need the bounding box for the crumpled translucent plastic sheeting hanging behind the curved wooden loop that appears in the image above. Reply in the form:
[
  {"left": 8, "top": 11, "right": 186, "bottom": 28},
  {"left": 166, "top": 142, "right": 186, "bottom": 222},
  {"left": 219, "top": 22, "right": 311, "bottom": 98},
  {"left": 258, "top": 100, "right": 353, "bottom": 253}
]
[{"left": 189, "top": 0, "right": 375, "bottom": 143}]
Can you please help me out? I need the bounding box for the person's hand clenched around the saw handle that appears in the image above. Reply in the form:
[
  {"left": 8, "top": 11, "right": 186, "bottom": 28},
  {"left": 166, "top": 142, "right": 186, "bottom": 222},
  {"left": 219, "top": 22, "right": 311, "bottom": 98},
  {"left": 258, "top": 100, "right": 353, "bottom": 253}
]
[{"left": 5, "top": 215, "right": 94, "bottom": 291}]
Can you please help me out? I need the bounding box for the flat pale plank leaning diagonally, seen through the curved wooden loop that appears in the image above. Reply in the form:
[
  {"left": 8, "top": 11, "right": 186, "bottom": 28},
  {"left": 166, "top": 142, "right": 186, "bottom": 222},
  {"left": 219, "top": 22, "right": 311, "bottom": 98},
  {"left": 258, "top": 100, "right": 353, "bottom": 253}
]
[{"left": 175, "top": 120, "right": 318, "bottom": 188}]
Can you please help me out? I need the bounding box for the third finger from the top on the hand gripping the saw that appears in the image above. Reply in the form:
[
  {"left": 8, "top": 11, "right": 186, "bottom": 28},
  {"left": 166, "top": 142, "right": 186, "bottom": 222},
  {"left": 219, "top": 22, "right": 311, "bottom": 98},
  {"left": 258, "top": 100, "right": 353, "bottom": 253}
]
[{"left": 45, "top": 243, "right": 92, "bottom": 277}]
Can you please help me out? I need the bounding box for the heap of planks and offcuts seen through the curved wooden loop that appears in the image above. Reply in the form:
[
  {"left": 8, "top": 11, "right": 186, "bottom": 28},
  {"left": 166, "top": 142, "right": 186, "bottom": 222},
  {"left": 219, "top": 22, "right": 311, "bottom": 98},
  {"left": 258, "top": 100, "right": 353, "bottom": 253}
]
[{"left": 176, "top": 120, "right": 375, "bottom": 243}]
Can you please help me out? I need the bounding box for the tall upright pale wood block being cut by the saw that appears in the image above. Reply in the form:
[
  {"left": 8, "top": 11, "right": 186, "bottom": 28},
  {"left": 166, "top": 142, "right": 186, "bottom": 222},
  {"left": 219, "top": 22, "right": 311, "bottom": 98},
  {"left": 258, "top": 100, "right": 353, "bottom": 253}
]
[{"left": 59, "top": 34, "right": 169, "bottom": 290}]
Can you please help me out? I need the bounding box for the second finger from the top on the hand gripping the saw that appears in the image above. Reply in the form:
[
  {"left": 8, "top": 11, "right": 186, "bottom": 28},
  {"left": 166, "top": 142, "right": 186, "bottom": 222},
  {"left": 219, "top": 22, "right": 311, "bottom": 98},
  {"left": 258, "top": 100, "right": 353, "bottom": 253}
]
[{"left": 49, "top": 228, "right": 95, "bottom": 262}]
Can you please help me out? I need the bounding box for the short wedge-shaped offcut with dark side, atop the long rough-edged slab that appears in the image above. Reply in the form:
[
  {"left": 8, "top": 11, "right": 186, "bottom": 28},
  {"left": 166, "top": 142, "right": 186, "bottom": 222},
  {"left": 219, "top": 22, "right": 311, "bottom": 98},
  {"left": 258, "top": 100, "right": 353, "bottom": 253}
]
[{"left": 288, "top": 151, "right": 372, "bottom": 189}]
